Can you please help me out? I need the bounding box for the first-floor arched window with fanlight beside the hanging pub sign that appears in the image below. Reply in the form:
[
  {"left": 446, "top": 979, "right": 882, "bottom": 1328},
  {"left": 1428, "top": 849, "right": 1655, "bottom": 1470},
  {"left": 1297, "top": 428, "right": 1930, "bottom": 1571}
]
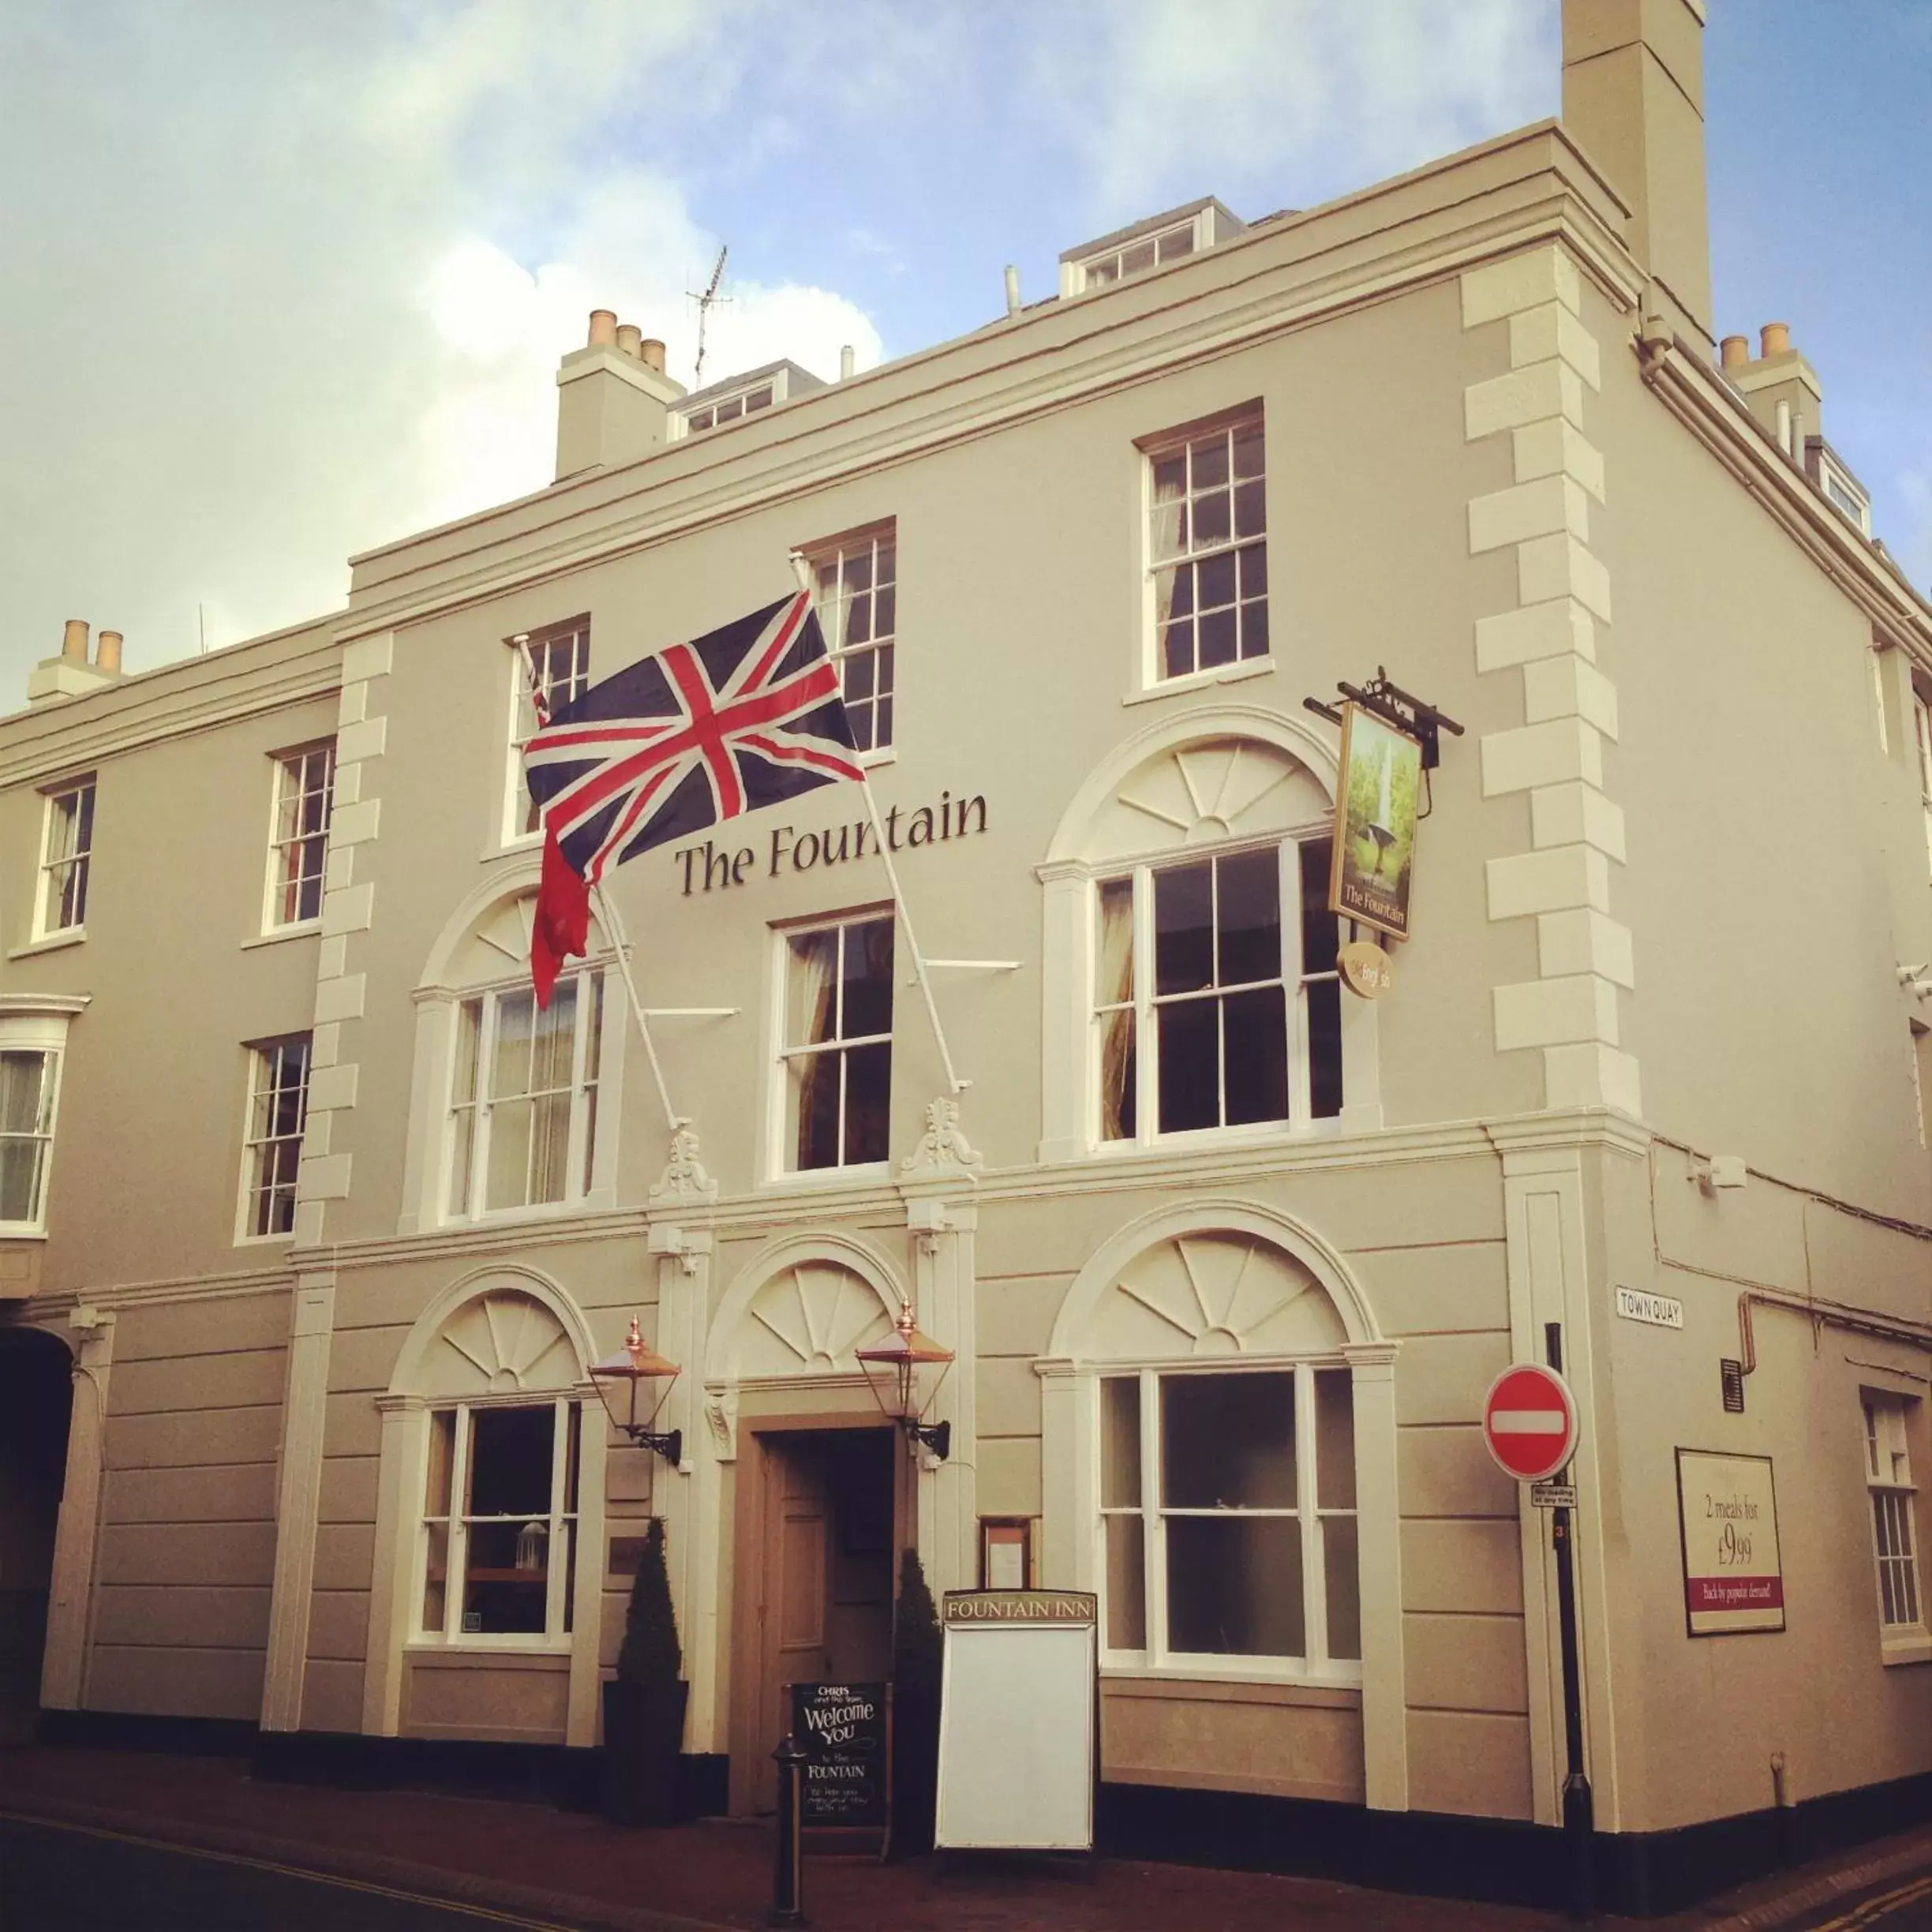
[{"left": 1041, "top": 711, "right": 1380, "bottom": 1159}]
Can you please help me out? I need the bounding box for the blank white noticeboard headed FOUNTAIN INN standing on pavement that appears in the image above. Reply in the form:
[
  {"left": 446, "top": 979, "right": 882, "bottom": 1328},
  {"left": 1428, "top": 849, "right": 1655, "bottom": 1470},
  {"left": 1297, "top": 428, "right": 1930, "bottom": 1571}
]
[{"left": 935, "top": 1590, "right": 1097, "bottom": 1851}]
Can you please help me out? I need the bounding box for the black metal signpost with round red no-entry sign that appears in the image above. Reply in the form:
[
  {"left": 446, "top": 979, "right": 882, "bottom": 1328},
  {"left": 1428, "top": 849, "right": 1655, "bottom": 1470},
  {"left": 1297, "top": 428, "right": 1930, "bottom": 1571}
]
[{"left": 1482, "top": 1344, "right": 1596, "bottom": 1919}]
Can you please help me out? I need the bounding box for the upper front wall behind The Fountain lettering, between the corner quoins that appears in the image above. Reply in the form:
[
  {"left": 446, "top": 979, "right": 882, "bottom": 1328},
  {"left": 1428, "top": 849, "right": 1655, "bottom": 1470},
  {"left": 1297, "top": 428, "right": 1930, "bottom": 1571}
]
[{"left": 328, "top": 268, "right": 1599, "bottom": 1238}]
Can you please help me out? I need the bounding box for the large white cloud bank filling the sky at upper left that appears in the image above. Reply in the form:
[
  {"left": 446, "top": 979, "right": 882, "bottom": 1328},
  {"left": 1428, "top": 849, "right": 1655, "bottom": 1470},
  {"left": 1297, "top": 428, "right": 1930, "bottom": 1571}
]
[{"left": 0, "top": 0, "right": 881, "bottom": 683}]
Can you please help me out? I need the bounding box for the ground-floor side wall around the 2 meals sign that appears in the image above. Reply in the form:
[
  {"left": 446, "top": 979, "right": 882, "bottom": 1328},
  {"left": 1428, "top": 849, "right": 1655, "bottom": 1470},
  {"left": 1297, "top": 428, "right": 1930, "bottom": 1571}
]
[{"left": 1594, "top": 1148, "right": 1932, "bottom": 1829}]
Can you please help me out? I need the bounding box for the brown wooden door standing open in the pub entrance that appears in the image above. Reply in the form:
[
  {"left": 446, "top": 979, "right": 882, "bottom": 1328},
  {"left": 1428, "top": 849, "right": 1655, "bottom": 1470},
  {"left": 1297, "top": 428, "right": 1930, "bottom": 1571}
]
[{"left": 751, "top": 1436, "right": 831, "bottom": 1812}]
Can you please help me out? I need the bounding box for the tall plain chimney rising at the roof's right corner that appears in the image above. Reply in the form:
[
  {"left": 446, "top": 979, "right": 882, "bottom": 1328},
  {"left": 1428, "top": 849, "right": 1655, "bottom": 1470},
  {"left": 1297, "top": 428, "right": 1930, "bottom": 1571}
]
[{"left": 1563, "top": 0, "right": 1712, "bottom": 354}]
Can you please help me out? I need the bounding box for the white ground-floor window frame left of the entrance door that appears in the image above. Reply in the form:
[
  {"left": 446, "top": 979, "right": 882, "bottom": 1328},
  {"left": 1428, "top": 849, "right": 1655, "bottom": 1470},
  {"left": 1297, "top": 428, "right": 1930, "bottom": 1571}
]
[{"left": 408, "top": 1391, "right": 579, "bottom": 1652}]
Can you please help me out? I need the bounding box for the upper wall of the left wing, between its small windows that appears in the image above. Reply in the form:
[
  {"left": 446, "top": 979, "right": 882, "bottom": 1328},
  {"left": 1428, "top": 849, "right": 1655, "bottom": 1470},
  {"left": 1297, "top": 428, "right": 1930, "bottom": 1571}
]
[{"left": 0, "top": 680, "right": 335, "bottom": 1294}]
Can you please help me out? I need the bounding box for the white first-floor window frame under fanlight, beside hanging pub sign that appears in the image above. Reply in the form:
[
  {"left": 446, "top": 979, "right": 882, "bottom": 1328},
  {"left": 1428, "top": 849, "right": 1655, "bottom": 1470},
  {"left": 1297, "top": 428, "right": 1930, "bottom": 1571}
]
[{"left": 1086, "top": 825, "right": 1349, "bottom": 1157}]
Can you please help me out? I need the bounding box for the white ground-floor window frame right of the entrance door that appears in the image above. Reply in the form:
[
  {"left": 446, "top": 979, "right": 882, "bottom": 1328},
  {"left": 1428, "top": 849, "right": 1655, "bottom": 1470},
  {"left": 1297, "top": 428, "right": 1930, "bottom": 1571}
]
[{"left": 1086, "top": 1354, "right": 1366, "bottom": 1687}]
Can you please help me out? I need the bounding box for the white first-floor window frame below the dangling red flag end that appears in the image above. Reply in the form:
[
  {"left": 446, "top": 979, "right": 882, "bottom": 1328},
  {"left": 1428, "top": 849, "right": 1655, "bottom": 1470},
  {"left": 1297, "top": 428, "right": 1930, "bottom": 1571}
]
[{"left": 436, "top": 960, "right": 622, "bottom": 1226}]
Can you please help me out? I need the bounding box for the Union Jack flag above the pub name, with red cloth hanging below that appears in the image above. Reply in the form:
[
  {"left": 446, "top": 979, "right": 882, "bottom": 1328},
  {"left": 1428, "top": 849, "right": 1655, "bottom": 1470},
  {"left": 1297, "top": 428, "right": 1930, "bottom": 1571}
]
[{"left": 523, "top": 591, "right": 863, "bottom": 1005}]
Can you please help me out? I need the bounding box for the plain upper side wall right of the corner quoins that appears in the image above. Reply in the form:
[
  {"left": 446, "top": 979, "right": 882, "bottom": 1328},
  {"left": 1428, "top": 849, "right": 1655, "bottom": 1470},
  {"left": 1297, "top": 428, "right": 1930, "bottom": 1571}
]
[{"left": 1592, "top": 287, "right": 1932, "bottom": 1221}]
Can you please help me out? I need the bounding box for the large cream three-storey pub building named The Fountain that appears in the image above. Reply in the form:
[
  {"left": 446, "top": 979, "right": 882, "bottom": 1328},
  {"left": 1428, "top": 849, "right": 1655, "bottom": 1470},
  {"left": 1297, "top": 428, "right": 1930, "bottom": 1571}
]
[{"left": 0, "top": 0, "right": 1932, "bottom": 1909}]
